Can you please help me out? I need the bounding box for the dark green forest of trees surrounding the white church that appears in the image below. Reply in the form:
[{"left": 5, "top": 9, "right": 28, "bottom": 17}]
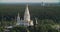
[{"left": 0, "top": 5, "right": 60, "bottom": 32}]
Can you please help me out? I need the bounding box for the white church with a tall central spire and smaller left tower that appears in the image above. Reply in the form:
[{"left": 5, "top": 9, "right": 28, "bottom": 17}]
[{"left": 16, "top": 5, "right": 33, "bottom": 26}]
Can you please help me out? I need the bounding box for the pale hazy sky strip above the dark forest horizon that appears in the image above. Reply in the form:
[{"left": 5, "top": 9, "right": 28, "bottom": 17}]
[{"left": 0, "top": 0, "right": 60, "bottom": 3}]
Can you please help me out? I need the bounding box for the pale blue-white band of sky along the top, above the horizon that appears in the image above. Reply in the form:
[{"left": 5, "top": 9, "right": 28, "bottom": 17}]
[{"left": 0, "top": 0, "right": 60, "bottom": 3}]
